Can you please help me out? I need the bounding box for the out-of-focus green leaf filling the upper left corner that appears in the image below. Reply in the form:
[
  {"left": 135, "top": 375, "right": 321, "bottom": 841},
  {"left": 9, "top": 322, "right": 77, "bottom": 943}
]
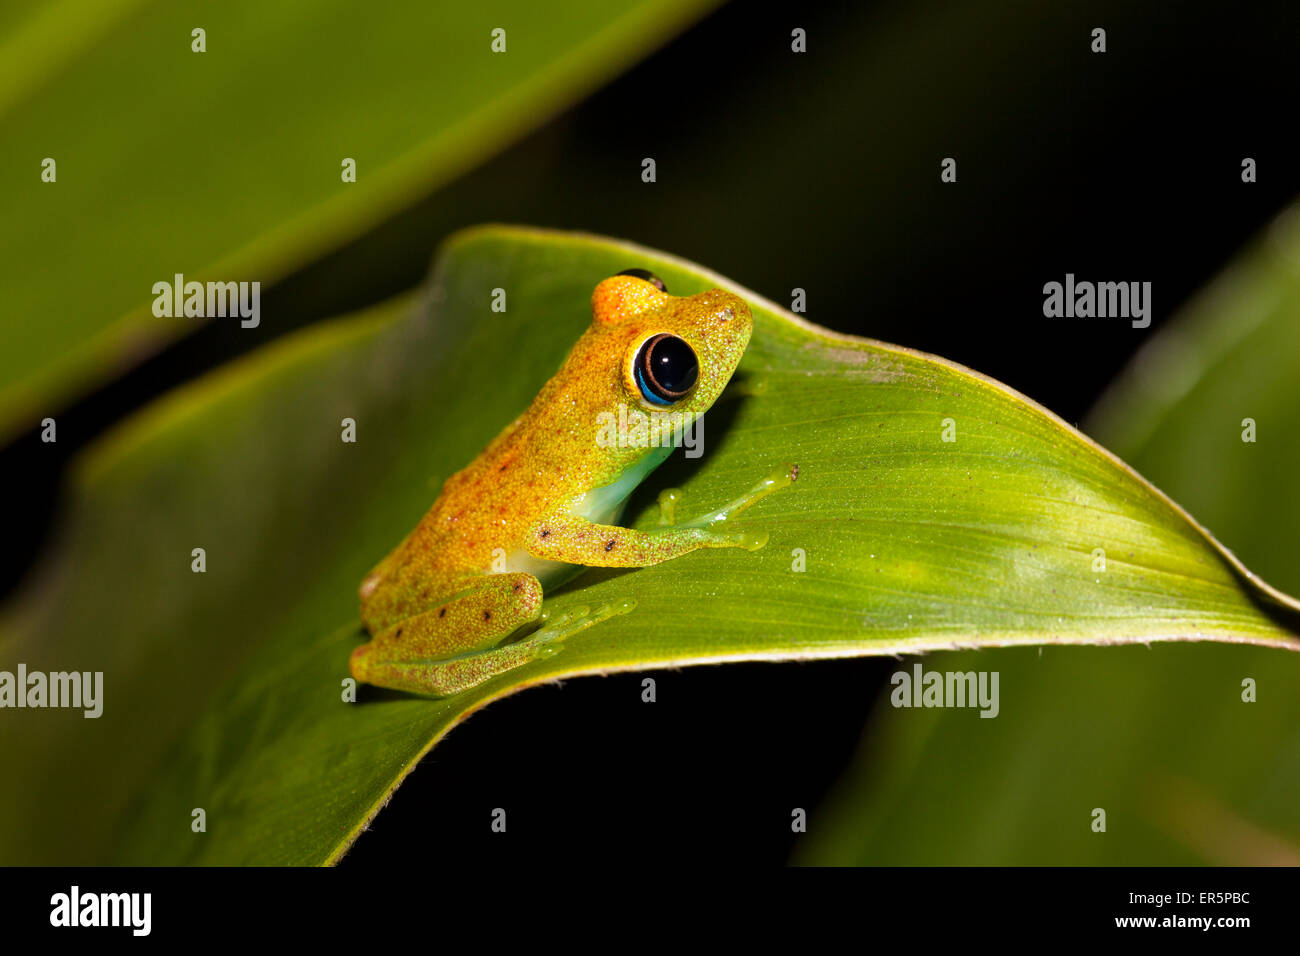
[{"left": 0, "top": 0, "right": 711, "bottom": 442}]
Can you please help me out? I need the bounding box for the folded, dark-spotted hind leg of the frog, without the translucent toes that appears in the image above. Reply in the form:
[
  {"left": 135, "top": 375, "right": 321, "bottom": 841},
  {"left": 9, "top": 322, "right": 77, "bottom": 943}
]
[{"left": 351, "top": 572, "right": 549, "bottom": 697}]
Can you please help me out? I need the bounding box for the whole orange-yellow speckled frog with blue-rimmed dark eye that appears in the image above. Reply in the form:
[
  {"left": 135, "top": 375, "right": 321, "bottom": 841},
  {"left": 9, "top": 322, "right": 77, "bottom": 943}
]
[{"left": 350, "top": 268, "right": 798, "bottom": 697}]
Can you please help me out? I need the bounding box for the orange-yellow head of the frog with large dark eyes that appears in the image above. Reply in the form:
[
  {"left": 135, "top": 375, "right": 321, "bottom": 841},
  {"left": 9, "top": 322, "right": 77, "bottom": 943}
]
[{"left": 592, "top": 269, "right": 754, "bottom": 414}]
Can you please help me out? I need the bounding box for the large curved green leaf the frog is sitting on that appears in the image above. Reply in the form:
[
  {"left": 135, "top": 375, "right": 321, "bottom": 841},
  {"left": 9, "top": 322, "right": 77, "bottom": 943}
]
[{"left": 0, "top": 228, "right": 1297, "bottom": 864}]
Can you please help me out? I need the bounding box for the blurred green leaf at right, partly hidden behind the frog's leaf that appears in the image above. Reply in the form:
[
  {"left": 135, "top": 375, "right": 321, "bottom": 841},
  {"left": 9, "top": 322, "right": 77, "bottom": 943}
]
[{"left": 797, "top": 209, "right": 1300, "bottom": 865}]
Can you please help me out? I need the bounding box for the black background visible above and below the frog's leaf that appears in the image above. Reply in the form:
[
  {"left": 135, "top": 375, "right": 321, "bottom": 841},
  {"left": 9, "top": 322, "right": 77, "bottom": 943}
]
[{"left": 0, "top": 0, "right": 1300, "bottom": 868}]
